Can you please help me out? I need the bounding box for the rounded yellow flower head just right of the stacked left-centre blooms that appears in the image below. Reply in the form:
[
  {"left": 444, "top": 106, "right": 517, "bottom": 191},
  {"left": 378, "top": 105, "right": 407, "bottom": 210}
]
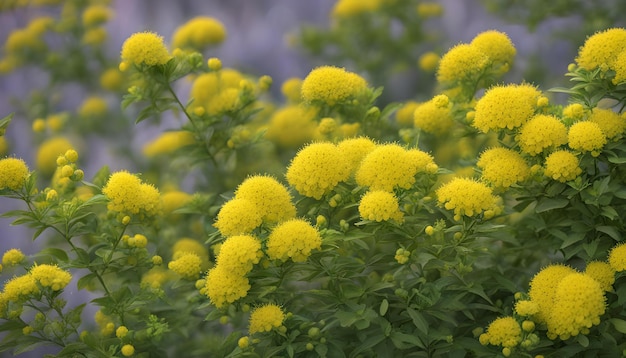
[{"left": 267, "top": 219, "right": 322, "bottom": 262}]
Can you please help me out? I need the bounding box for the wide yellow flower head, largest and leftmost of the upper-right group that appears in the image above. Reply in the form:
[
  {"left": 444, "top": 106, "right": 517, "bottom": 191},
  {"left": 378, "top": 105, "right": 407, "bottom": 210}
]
[{"left": 473, "top": 84, "right": 541, "bottom": 133}]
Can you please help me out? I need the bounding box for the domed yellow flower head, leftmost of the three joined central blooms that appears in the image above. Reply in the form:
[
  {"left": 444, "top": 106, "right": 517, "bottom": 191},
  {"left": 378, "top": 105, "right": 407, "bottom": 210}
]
[{"left": 285, "top": 142, "right": 350, "bottom": 200}]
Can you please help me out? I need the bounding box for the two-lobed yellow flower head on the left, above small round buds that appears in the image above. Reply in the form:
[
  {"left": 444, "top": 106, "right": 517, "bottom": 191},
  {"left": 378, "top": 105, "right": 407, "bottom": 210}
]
[{"left": 102, "top": 171, "right": 161, "bottom": 218}]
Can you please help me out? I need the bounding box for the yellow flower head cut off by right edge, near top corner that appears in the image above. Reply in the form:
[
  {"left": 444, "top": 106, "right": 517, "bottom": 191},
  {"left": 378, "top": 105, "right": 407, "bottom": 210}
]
[{"left": 576, "top": 28, "right": 626, "bottom": 71}]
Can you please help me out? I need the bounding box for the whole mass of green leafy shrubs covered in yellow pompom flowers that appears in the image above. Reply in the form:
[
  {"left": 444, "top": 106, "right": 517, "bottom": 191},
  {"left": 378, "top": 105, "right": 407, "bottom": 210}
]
[{"left": 0, "top": 0, "right": 626, "bottom": 357}]
